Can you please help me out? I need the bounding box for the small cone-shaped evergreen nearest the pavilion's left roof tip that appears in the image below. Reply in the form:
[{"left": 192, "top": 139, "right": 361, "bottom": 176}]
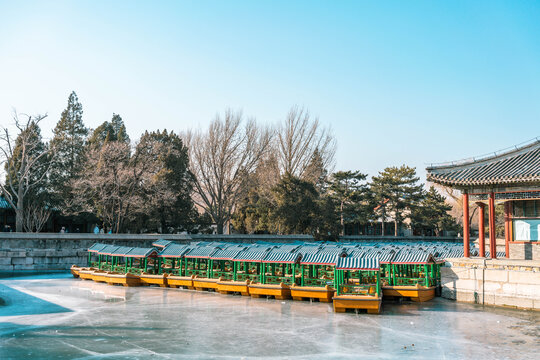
[{"left": 411, "top": 186, "right": 457, "bottom": 235}]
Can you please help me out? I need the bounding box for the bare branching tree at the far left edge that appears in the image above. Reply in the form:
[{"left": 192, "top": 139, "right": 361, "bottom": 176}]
[{"left": 0, "top": 111, "right": 52, "bottom": 232}]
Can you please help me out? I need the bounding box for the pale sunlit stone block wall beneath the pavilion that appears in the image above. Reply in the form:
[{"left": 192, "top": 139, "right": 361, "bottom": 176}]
[{"left": 441, "top": 258, "right": 540, "bottom": 310}]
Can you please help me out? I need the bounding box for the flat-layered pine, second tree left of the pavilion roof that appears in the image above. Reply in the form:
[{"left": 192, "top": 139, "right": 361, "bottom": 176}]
[{"left": 370, "top": 165, "right": 422, "bottom": 236}]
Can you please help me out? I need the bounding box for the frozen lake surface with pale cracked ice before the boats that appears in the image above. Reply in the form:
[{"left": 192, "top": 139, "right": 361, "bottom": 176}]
[{"left": 0, "top": 274, "right": 540, "bottom": 359}]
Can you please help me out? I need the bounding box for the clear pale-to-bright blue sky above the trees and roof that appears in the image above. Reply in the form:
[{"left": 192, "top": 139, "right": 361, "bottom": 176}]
[{"left": 0, "top": 0, "right": 540, "bottom": 178}]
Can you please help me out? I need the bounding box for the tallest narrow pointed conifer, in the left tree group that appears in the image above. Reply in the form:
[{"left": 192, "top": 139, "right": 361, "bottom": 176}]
[{"left": 49, "top": 91, "right": 88, "bottom": 209}]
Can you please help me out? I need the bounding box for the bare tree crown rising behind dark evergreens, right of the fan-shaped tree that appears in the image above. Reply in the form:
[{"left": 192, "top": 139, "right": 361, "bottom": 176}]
[{"left": 276, "top": 106, "right": 336, "bottom": 178}]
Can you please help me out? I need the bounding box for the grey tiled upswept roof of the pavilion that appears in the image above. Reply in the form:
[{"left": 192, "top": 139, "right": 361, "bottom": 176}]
[{"left": 426, "top": 138, "right": 540, "bottom": 187}]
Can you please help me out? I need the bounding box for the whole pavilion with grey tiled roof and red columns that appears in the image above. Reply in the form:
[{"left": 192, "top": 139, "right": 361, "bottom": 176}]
[{"left": 426, "top": 138, "right": 540, "bottom": 258}]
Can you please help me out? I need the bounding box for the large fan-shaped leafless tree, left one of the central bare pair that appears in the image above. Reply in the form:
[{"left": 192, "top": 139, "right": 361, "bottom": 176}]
[{"left": 184, "top": 110, "right": 272, "bottom": 234}]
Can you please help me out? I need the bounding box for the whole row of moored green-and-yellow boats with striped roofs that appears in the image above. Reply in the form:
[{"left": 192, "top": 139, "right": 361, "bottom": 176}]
[{"left": 71, "top": 240, "right": 463, "bottom": 313}]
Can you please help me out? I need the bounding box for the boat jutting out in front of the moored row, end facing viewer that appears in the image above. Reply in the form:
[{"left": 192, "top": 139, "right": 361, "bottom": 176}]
[{"left": 333, "top": 257, "right": 382, "bottom": 314}]
